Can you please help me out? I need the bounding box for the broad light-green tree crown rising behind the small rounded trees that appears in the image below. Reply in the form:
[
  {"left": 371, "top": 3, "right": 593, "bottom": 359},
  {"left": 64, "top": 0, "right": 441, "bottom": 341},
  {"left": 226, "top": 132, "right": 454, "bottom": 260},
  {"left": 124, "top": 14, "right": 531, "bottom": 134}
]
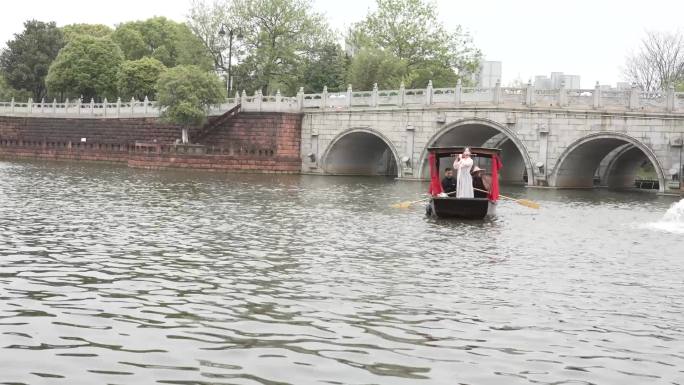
[{"left": 112, "top": 17, "right": 212, "bottom": 69}]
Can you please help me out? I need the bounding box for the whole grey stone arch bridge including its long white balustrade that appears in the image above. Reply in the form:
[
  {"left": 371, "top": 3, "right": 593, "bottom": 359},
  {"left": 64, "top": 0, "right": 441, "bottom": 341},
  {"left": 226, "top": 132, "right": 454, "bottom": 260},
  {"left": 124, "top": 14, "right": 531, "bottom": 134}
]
[{"left": 0, "top": 83, "right": 684, "bottom": 192}]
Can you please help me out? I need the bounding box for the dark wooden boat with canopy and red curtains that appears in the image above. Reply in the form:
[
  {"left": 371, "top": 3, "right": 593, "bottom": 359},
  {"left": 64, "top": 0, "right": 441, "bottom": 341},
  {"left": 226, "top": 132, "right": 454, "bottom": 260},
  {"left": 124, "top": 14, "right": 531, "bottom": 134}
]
[{"left": 426, "top": 147, "right": 501, "bottom": 219}]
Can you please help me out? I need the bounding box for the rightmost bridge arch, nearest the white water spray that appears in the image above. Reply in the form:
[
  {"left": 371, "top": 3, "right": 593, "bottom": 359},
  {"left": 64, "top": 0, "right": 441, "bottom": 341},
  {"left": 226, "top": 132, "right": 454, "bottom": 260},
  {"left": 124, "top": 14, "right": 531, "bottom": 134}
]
[{"left": 550, "top": 132, "right": 665, "bottom": 192}]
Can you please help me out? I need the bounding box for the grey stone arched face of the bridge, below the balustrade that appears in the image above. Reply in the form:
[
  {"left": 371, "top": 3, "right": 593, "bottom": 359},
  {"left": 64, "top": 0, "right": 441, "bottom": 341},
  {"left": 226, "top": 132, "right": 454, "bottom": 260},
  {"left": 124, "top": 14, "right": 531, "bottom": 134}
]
[{"left": 302, "top": 106, "right": 684, "bottom": 192}]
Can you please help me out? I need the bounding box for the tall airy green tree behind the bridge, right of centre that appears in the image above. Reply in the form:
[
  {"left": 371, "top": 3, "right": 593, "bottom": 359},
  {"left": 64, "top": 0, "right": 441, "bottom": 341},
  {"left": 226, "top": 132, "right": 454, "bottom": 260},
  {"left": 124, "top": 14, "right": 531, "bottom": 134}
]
[{"left": 347, "top": 0, "right": 481, "bottom": 88}]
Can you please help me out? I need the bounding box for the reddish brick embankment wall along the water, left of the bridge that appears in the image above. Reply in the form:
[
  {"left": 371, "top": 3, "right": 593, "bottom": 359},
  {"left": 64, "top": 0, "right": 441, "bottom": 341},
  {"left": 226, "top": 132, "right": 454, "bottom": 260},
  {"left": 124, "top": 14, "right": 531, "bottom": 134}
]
[{"left": 0, "top": 113, "right": 302, "bottom": 173}]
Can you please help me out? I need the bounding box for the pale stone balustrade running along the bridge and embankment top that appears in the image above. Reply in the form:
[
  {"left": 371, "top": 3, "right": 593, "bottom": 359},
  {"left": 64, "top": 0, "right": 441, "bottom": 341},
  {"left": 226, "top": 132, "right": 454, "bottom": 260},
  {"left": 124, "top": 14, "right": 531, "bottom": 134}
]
[{"left": 0, "top": 81, "right": 684, "bottom": 118}]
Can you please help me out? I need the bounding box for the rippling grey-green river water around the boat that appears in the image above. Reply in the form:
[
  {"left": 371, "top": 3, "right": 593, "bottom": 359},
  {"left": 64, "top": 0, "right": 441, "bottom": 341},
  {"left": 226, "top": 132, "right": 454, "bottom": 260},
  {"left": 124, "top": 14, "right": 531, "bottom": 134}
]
[{"left": 0, "top": 162, "right": 684, "bottom": 385}]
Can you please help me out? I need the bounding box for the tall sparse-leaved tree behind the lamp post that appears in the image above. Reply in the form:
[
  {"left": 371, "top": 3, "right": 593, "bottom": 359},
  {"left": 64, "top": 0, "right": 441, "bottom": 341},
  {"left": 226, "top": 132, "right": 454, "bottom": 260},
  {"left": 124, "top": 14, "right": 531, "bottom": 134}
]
[{"left": 189, "top": 0, "right": 335, "bottom": 94}]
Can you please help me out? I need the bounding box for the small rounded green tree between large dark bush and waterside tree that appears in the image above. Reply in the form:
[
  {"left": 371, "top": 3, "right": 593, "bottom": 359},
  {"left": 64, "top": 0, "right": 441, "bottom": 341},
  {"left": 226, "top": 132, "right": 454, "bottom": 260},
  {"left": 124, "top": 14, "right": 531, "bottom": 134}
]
[{"left": 117, "top": 57, "right": 166, "bottom": 100}]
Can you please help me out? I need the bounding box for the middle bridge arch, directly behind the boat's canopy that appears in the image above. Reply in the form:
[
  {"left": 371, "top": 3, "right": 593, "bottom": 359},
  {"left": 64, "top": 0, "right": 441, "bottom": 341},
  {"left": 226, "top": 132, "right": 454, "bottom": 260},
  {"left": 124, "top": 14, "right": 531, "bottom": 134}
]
[{"left": 419, "top": 118, "right": 534, "bottom": 185}]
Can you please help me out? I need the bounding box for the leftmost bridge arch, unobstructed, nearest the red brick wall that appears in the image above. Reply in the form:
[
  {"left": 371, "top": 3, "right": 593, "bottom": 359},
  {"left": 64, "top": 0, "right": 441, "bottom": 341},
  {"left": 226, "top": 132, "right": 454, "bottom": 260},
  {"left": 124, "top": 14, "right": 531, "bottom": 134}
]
[{"left": 321, "top": 128, "right": 401, "bottom": 177}]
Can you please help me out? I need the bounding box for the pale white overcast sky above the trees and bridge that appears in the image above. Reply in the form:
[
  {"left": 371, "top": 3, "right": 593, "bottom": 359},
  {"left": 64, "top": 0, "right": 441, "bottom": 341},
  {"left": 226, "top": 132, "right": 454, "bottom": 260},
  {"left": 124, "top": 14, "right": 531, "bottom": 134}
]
[{"left": 0, "top": 0, "right": 684, "bottom": 87}]
